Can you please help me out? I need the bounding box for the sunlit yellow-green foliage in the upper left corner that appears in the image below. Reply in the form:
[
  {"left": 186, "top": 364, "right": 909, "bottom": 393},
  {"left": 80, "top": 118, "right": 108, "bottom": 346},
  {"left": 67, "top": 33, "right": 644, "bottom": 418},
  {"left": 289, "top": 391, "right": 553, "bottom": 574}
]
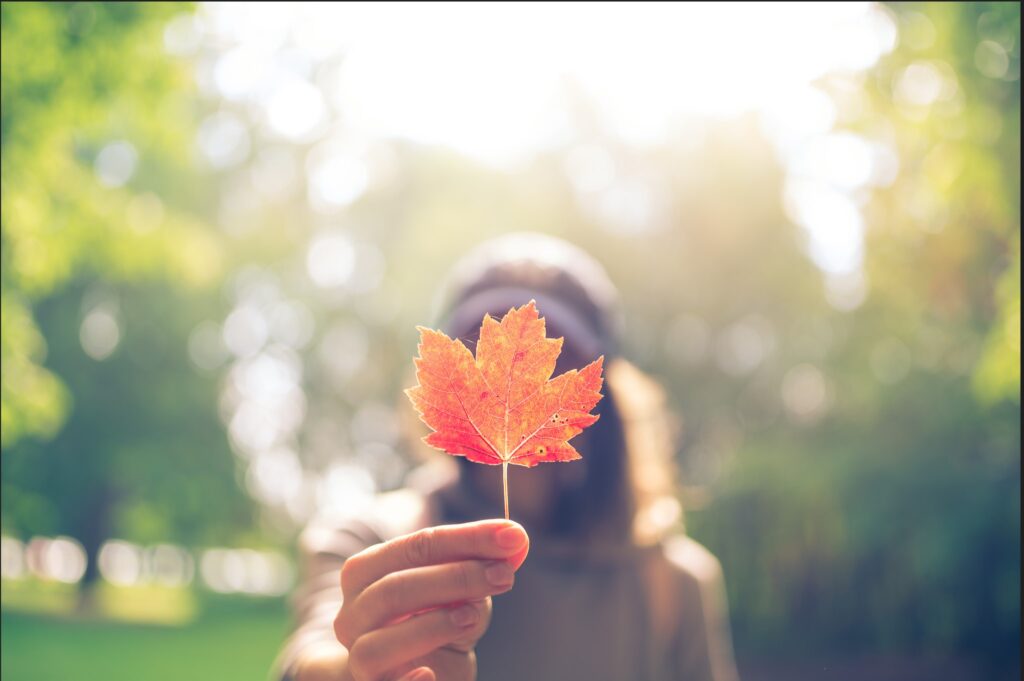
[{"left": 0, "top": 2, "right": 219, "bottom": 445}]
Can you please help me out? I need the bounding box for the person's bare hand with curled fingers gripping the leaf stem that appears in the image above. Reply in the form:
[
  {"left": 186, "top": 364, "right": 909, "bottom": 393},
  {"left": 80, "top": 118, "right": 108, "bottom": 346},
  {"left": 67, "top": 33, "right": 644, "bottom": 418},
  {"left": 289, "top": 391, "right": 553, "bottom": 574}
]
[{"left": 334, "top": 520, "right": 529, "bottom": 681}]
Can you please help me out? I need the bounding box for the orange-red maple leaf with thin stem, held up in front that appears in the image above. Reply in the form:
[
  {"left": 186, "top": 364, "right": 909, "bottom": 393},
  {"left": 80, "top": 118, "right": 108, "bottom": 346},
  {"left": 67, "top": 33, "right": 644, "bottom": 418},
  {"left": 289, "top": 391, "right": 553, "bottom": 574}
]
[{"left": 406, "top": 300, "right": 604, "bottom": 518}]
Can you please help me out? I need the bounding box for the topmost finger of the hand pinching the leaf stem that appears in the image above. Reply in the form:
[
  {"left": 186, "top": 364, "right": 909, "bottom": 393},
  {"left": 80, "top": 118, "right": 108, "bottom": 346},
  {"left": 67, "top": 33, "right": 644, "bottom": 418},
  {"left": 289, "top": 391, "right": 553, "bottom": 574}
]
[{"left": 341, "top": 520, "right": 529, "bottom": 599}]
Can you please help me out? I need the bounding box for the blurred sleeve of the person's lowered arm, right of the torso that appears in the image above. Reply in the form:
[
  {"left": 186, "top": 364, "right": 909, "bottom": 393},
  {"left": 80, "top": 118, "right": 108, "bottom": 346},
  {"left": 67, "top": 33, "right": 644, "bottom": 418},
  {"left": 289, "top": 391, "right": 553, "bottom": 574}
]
[{"left": 666, "top": 537, "right": 738, "bottom": 681}]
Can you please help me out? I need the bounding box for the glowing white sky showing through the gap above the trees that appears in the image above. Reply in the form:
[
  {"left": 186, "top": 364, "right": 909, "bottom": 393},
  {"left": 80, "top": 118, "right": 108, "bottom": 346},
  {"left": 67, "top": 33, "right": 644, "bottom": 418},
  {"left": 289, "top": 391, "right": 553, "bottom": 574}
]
[{"left": 159, "top": 2, "right": 905, "bottom": 308}]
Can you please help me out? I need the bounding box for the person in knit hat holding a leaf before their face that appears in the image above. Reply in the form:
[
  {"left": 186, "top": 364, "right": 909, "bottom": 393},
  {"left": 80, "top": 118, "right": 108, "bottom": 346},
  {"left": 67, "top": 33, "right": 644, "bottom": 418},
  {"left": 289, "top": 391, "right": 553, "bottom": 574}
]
[{"left": 278, "top": 233, "right": 736, "bottom": 681}]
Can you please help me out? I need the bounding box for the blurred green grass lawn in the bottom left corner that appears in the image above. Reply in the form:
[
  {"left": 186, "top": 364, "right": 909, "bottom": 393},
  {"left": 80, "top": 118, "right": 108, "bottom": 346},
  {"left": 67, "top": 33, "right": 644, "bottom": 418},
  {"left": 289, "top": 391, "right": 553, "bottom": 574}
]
[{"left": 0, "top": 585, "right": 288, "bottom": 681}]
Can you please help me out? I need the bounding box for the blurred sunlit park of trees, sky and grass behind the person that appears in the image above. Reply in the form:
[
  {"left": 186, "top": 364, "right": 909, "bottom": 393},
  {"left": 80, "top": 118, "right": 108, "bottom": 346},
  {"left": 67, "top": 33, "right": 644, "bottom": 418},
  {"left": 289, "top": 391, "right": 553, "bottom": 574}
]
[{"left": 0, "top": 2, "right": 1021, "bottom": 680}]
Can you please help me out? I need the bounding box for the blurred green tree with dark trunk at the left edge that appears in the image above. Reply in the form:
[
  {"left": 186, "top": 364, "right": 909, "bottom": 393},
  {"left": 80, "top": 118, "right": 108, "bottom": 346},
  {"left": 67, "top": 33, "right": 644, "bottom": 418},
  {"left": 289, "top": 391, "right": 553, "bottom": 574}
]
[{"left": 0, "top": 3, "right": 251, "bottom": 583}]
